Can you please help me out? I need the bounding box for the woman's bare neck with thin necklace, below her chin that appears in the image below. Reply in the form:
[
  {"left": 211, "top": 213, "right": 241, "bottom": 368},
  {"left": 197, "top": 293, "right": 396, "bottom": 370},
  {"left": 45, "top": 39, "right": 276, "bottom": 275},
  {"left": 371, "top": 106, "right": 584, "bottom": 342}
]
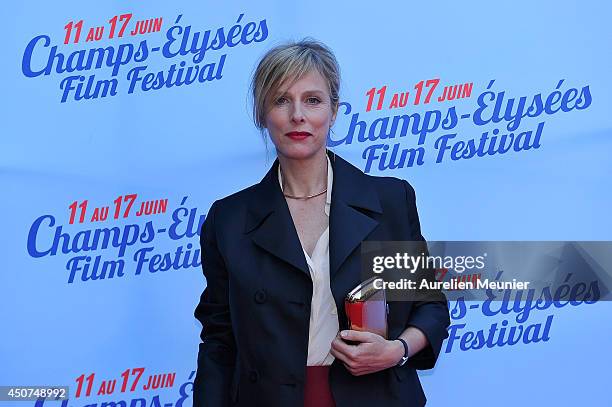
[{"left": 278, "top": 150, "right": 327, "bottom": 196}]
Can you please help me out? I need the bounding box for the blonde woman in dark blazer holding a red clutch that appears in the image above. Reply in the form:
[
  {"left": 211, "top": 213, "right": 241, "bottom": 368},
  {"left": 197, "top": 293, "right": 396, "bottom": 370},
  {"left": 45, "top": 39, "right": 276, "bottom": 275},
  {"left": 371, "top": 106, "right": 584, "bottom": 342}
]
[{"left": 194, "top": 41, "right": 449, "bottom": 407}]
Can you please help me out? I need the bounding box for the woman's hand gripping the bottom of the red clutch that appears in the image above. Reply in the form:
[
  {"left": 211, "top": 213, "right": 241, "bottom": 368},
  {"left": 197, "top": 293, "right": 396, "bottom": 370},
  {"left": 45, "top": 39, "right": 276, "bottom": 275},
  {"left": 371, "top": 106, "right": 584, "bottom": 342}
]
[{"left": 331, "top": 330, "right": 404, "bottom": 376}]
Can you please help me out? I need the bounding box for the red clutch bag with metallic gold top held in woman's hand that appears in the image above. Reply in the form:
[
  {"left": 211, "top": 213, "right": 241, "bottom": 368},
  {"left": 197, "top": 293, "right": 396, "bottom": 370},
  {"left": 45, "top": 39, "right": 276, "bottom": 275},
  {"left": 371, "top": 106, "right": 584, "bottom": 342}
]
[{"left": 344, "top": 277, "right": 387, "bottom": 339}]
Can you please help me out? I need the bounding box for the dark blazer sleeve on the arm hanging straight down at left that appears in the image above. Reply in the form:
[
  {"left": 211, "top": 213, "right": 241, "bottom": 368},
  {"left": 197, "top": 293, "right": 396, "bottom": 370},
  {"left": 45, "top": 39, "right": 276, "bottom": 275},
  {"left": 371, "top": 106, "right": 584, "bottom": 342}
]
[{"left": 193, "top": 202, "right": 236, "bottom": 407}]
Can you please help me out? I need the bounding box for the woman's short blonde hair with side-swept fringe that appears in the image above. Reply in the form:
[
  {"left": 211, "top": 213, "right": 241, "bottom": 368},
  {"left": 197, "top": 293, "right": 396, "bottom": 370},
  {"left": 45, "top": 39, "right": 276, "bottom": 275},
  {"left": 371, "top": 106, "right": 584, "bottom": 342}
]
[{"left": 251, "top": 38, "right": 340, "bottom": 130}]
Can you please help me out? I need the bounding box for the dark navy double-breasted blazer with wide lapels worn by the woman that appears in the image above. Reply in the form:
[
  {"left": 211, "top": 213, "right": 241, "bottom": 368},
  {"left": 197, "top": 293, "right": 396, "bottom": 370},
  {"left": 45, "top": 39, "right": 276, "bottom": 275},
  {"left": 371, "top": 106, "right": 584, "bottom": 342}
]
[{"left": 193, "top": 153, "right": 450, "bottom": 407}]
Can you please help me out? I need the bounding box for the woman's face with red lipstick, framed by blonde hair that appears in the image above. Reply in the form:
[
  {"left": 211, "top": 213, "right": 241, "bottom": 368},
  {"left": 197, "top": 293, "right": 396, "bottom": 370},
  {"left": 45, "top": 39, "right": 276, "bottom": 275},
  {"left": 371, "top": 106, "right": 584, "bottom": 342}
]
[{"left": 265, "top": 71, "right": 336, "bottom": 160}]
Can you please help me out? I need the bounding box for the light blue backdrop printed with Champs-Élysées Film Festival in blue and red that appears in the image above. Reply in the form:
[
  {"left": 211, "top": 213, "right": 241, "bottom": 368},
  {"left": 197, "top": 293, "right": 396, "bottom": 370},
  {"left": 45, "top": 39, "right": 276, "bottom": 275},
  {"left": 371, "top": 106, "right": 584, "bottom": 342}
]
[{"left": 0, "top": 0, "right": 612, "bottom": 407}]
